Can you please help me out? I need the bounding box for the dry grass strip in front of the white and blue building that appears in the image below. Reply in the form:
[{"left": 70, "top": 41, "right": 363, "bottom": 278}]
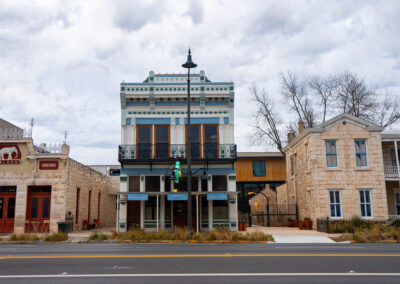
[{"left": 111, "top": 228, "right": 273, "bottom": 242}]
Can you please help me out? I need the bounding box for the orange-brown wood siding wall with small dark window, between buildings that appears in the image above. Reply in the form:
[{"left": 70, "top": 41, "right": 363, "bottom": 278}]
[{"left": 236, "top": 157, "right": 286, "bottom": 182}]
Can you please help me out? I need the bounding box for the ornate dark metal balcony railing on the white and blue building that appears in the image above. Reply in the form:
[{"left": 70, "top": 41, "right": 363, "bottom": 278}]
[{"left": 118, "top": 142, "right": 236, "bottom": 162}]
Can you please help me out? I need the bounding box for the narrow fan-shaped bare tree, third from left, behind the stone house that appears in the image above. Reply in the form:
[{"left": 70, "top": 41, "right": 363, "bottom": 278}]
[{"left": 307, "top": 75, "right": 337, "bottom": 122}]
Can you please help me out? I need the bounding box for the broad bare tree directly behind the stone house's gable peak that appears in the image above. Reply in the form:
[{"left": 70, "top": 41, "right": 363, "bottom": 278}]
[{"left": 336, "top": 71, "right": 378, "bottom": 121}]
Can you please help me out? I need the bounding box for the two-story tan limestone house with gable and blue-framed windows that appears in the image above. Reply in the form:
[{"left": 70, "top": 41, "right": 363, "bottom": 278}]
[{"left": 278, "top": 114, "right": 390, "bottom": 226}]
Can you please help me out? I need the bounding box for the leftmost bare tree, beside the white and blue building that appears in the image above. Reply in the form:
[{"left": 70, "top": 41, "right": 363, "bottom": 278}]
[{"left": 250, "top": 86, "right": 284, "bottom": 154}]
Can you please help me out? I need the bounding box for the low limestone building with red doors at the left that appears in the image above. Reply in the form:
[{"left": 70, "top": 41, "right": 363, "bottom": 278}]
[{"left": 0, "top": 120, "right": 119, "bottom": 233}]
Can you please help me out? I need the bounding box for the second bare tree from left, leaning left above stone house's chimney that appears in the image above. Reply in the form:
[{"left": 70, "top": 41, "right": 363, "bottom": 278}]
[{"left": 281, "top": 71, "right": 316, "bottom": 127}]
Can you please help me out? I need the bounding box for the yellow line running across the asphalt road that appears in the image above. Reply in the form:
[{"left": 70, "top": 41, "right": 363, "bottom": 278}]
[{"left": 0, "top": 253, "right": 400, "bottom": 260}]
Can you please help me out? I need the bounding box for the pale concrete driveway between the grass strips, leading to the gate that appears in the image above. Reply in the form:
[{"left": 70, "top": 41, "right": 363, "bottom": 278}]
[{"left": 247, "top": 227, "right": 338, "bottom": 243}]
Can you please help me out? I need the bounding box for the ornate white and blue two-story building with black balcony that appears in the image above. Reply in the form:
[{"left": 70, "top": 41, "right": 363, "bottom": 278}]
[{"left": 117, "top": 71, "right": 237, "bottom": 232}]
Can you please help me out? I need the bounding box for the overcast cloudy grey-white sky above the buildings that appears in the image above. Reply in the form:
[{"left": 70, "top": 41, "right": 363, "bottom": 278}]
[{"left": 0, "top": 0, "right": 400, "bottom": 164}]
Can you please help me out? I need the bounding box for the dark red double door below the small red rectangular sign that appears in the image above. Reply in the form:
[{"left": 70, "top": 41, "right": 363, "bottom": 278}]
[{"left": 26, "top": 186, "right": 51, "bottom": 233}]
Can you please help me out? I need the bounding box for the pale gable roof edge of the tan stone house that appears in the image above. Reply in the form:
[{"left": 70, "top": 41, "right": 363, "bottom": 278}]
[{"left": 283, "top": 113, "right": 385, "bottom": 152}]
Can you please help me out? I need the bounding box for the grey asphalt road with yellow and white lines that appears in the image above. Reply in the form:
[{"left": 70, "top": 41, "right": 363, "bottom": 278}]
[{"left": 0, "top": 243, "right": 400, "bottom": 284}]
